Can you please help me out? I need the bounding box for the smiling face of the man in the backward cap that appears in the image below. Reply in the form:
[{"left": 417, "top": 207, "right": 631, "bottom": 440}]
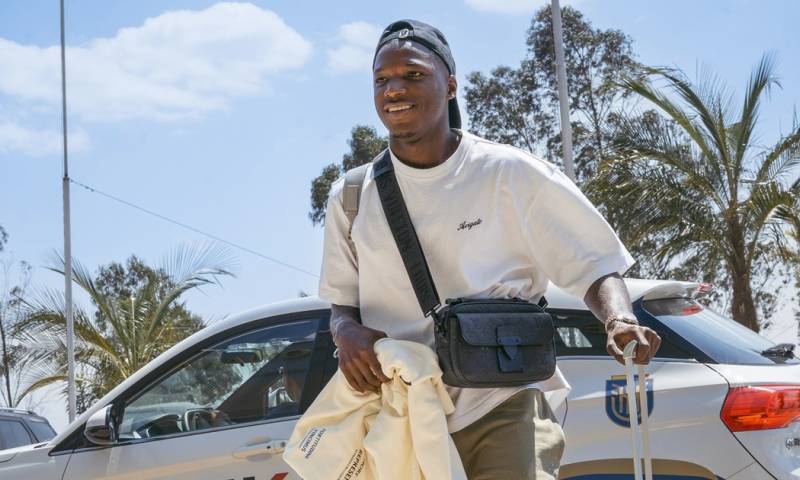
[{"left": 373, "top": 41, "right": 456, "bottom": 138}]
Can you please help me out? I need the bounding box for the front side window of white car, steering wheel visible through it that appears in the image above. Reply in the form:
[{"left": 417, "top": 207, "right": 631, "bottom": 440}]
[{"left": 119, "top": 319, "right": 319, "bottom": 439}]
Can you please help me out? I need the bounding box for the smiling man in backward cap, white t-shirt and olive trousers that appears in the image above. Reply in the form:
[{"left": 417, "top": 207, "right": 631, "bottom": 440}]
[{"left": 319, "top": 20, "right": 660, "bottom": 479}]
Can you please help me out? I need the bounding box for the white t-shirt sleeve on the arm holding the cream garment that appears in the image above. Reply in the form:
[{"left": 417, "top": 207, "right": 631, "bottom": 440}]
[{"left": 319, "top": 177, "right": 358, "bottom": 307}]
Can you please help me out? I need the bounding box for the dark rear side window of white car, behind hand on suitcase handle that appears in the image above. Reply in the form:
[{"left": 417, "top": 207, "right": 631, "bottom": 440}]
[{"left": 550, "top": 310, "right": 692, "bottom": 360}]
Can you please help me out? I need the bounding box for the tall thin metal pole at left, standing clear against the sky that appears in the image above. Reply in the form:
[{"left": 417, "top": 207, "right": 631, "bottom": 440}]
[{"left": 60, "top": 0, "right": 77, "bottom": 422}]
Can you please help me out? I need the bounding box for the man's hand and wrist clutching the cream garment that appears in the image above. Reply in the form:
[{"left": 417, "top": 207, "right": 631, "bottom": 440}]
[{"left": 331, "top": 305, "right": 389, "bottom": 393}]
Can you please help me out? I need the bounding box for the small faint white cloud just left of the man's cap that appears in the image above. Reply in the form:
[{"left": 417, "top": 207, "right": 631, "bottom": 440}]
[{"left": 328, "top": 22, "right": 382, "bottom": 73}]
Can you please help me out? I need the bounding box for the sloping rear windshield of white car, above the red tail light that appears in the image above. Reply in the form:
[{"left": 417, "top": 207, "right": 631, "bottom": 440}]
[{"left": 643, "top": 298, "right": 800, "bottom": 365}]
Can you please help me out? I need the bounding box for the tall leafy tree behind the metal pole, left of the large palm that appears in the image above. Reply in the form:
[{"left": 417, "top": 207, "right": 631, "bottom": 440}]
[{"left": 465, "top": 7, "right": 639, "bottom": 179}]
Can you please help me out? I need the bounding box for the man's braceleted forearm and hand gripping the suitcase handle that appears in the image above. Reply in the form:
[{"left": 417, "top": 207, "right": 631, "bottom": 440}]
[{"left": 583, "top": 273, "right": 661, "bottom": 364}]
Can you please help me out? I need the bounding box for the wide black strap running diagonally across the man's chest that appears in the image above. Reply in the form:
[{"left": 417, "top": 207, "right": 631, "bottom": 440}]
[{"left": 372, "top": 148, "right": 441, "bottom": 317}]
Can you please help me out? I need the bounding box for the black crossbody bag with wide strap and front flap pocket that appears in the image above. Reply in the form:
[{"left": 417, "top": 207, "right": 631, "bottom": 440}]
[{"left": 373, "top": 149, "right": 556, "bottom": 388}]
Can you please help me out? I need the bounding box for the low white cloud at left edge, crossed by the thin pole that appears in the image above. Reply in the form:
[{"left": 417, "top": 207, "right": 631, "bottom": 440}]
[{"left": 0, "top": 119, "right": 89, "bottom": 157}]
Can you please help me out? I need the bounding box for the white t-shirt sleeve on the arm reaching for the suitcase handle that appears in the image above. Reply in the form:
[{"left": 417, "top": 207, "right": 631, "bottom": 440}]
[{"left": 523, "top": 160, "right": 635, "bottom": 299}]
